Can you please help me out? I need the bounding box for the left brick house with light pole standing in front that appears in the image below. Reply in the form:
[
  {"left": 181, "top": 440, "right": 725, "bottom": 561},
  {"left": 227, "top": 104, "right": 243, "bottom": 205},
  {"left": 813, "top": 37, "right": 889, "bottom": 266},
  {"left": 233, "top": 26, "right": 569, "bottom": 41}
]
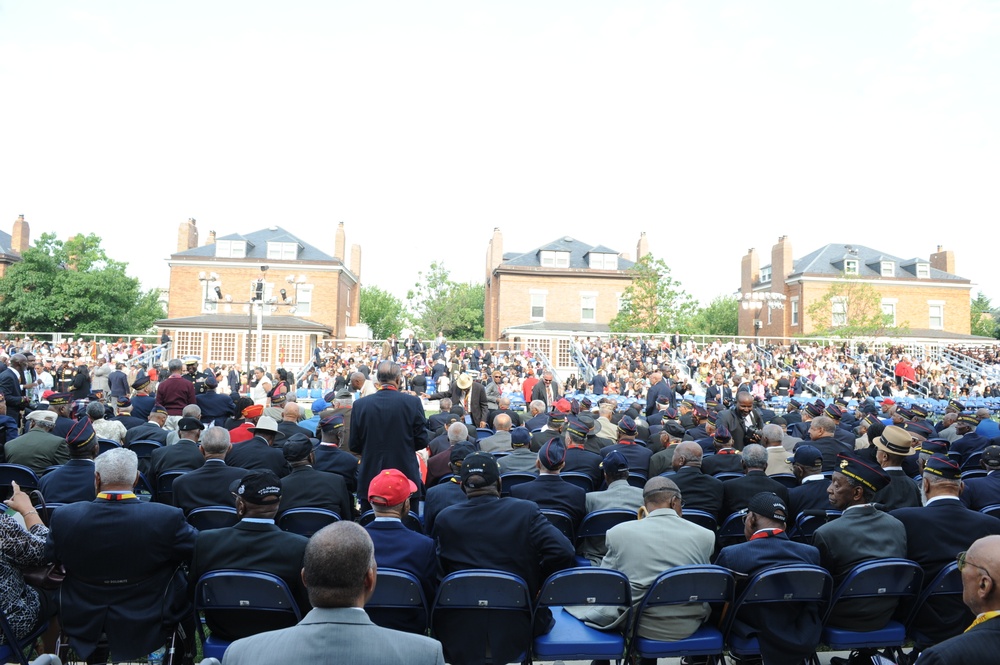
[{"left": 162, "top": 219, "right": 361, "bottom": 369}]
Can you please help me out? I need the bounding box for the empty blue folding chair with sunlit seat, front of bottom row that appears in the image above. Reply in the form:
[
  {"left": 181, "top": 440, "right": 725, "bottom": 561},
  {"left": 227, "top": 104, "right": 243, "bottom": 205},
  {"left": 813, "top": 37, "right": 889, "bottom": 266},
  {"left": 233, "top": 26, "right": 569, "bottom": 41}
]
[{"left": 533, "top": 568, "right": 632, "bottom": 660}]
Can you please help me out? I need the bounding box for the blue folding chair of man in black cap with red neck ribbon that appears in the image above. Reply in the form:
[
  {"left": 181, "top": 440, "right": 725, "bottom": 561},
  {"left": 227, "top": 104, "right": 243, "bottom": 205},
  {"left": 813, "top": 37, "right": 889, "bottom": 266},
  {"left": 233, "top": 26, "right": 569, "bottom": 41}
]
[{"left": 722, "top": 565, "right": 833, "bottom": 659}]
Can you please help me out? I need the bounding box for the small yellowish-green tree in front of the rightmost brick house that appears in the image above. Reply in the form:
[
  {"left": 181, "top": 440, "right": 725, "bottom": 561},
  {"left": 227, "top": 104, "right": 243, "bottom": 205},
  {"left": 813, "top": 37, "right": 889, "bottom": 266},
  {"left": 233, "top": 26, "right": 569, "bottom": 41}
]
[{"left": 808, "top": 275, "right": 907, "bottom": 337}]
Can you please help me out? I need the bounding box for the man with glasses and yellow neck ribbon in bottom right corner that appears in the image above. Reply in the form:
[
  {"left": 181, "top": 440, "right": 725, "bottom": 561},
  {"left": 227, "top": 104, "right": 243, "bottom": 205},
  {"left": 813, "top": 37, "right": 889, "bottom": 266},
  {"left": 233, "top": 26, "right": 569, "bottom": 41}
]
[{"left": 917, "top": 536, "right": 1000, "bottom": 665}]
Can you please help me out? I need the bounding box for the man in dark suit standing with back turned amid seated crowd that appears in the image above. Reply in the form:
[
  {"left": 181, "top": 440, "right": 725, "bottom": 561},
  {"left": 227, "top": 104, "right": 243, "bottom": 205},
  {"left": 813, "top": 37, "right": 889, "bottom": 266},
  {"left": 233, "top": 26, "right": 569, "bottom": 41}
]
[{"left": 350, "top": 360, "right": 428, "bottom": 510}]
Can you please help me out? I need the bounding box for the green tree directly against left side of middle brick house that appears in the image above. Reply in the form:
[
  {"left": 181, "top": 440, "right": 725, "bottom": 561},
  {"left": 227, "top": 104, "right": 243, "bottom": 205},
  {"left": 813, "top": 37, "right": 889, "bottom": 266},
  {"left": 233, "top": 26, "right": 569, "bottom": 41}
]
[{"left": 406, "top": 261, "right": 486, "bottom": 339}]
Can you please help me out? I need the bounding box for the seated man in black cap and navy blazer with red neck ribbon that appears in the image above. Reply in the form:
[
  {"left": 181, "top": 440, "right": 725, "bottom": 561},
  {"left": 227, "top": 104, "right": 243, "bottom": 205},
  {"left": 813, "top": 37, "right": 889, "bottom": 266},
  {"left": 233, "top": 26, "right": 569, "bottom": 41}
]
[{"left": 715, "top": 490, "right": 823, "bottom": 665}]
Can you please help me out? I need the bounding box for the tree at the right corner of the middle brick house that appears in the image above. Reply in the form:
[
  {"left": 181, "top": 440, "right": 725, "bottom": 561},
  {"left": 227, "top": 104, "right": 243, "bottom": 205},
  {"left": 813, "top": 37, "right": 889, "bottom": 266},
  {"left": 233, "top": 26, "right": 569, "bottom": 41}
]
[{"left": 611, "top": 254, "right": 698, "bottom": 333}]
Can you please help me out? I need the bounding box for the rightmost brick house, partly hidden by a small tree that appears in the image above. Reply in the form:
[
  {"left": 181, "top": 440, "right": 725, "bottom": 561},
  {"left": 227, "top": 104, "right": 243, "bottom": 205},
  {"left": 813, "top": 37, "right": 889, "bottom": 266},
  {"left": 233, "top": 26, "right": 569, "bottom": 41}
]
[{"left": 739, "top": 236, "right": 972, "bottom": 338}]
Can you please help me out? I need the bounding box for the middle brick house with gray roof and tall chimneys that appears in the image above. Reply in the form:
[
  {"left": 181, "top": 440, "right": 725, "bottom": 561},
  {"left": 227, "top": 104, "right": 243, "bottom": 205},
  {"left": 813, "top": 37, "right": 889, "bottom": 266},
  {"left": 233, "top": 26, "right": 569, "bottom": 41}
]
[{"left": 484, "top": 228, "right": 649, "bottom": 367}]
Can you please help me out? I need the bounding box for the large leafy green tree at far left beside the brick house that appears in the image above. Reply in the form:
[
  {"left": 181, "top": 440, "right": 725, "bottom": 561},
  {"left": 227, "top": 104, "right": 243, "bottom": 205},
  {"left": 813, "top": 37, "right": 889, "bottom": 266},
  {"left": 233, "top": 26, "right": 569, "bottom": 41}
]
[{"left": 0, "top": 233, "right": 166, "bottom": 334}]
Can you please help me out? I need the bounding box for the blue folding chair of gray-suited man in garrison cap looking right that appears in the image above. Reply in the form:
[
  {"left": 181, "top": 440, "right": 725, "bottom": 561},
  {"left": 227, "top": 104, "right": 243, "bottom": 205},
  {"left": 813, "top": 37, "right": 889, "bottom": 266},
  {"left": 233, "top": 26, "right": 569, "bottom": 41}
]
[{"left": 823, "top": 558, "right": 924, "bottom": 651}]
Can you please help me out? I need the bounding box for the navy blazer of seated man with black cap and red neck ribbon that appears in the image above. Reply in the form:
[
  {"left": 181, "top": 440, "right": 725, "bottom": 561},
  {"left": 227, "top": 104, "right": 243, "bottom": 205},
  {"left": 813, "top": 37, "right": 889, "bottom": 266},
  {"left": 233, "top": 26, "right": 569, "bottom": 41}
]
[{"left": 715, "top": 532, "right": 825, "bottom": 665}]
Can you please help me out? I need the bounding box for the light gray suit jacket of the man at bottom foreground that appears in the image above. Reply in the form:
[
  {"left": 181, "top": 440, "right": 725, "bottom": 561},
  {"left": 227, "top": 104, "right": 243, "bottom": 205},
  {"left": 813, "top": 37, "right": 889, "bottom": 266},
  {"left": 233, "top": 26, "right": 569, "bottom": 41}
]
[{"left": 222, "top": 607, "right": 444, "bottom": 665}]
